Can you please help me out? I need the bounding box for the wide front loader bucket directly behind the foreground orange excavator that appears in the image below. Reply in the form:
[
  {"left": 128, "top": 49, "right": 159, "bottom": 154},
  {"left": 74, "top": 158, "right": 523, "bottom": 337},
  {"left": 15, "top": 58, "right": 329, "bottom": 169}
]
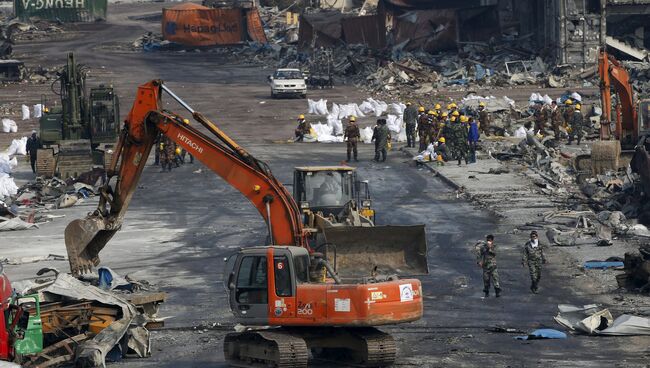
[{"left": 323, "top": 225, "right": 429, "bottom": 278}]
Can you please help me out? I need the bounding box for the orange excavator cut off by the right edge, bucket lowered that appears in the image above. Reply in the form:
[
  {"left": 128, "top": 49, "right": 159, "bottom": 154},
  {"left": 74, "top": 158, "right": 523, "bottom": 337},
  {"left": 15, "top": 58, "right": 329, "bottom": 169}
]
[{"left": 591, "top": 48, "right": 650, "bottom": 193}]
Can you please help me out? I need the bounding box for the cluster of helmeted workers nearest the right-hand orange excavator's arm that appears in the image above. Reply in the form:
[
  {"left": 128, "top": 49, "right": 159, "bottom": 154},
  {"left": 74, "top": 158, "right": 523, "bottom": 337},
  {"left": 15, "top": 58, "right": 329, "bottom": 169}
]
[{"left": 533, "top": 98, "right": 585, "bottom": 144}]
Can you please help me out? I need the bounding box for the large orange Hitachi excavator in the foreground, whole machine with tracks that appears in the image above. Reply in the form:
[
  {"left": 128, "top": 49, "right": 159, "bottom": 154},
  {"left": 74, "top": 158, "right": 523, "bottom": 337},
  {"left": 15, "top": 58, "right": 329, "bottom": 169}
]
[{"left": 65, "top": 80, "right": 423, "bottom": 367}]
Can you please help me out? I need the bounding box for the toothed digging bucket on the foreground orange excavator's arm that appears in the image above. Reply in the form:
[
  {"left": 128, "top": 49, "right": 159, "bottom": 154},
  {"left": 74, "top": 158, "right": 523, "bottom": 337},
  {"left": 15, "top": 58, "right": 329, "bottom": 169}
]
[{"left": 65, "top": 217, "right": 117, "bottom": 275}]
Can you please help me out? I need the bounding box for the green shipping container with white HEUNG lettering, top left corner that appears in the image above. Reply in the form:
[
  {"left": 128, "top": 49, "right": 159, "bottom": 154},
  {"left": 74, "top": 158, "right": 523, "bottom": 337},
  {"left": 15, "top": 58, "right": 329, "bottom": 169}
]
[{"left": 14, "top": 0, "right": 108, "bottom": 22}]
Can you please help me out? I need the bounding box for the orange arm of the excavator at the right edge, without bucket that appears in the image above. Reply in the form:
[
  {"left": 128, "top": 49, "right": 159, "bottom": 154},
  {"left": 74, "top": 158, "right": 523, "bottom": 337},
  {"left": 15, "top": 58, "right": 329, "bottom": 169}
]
[{"left": 598, "top": 48, "right": 639, "bottom": 146}]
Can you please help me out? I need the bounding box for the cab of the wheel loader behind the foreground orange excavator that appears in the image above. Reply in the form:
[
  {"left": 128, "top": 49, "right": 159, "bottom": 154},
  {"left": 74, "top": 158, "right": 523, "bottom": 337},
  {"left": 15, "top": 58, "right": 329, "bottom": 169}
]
[{"left": 293, "top": 166, "right": 374, "bottom": 218}]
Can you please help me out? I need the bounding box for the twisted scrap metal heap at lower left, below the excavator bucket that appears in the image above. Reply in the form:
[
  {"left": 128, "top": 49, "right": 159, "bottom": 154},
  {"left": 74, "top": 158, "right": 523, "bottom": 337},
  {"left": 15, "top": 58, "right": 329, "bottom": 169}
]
[{"left": 14, "top": 268, "right": 165, "bottom": 367}]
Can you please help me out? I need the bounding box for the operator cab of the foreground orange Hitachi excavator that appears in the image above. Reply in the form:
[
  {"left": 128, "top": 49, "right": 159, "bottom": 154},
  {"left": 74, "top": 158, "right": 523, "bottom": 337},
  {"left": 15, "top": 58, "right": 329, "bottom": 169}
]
[{"left": 223, "top": 246, "right": 309, "bottom": 325}]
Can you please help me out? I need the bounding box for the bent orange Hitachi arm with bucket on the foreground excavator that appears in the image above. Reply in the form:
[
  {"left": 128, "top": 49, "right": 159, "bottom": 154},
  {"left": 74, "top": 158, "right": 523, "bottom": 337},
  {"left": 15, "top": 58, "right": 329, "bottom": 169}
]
[{"left": 65, "top": 80, "right": 309, "bottom": 274}]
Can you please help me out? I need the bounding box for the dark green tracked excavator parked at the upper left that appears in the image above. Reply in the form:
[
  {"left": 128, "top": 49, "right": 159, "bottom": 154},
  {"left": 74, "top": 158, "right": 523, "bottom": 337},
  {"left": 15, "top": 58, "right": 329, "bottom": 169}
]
[{"left": 36, "top": 53, "right": 120, "bottom": 179}]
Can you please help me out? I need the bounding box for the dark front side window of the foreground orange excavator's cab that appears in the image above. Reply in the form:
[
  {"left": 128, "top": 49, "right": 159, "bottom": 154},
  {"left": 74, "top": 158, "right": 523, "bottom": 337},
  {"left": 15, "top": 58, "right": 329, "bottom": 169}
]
[{"left": 235, "top": 256, "right": 268, "bottom": 304}]
